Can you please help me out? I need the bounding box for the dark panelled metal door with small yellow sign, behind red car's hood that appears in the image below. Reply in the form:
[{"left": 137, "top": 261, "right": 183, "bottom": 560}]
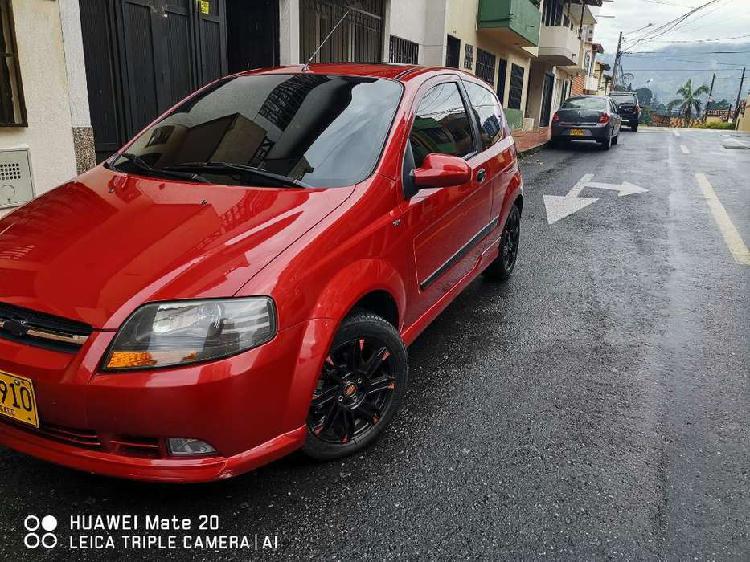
[{"left": 80, "top": 0, "right": 227, "bottom": 161}]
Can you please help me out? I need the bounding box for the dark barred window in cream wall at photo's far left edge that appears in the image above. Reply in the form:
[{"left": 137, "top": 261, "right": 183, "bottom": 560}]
[{"left": 0, "top": 0, "right": 26, "bottom": 127}]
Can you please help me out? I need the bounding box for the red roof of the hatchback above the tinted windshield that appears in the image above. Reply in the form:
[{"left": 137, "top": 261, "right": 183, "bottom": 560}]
[{"left": 249, "top": 63, "right": 473, "bottom": 82}]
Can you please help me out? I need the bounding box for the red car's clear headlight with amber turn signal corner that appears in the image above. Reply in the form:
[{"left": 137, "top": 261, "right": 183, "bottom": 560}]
[{"left": 104, "top": 297, "right": 276, "bottom": 371}]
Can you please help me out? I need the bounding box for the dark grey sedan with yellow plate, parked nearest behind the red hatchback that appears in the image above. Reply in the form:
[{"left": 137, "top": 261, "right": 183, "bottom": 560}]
[{"left": 552, "top": 96, "right": 622, "bottom": 150}]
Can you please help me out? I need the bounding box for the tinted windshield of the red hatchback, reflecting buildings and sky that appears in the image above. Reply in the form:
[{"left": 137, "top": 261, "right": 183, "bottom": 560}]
[{"left": 108, "top": 74, "right": 402, "bottom": 187}]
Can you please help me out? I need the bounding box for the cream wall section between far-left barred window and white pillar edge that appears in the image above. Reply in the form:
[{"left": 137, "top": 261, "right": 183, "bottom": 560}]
[{"left": 0, "top": 0, "right": 76, "bottom": 195}]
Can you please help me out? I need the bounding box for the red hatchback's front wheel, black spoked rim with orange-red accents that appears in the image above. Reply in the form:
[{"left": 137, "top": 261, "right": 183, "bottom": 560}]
[{"left": 302, "top": 312, "right": 409, "bottom": 460}]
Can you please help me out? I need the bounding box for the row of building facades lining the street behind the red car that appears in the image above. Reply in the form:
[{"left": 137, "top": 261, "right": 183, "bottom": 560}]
[{"left": 0, "top": 0, "right": 602, "bottom": 217}]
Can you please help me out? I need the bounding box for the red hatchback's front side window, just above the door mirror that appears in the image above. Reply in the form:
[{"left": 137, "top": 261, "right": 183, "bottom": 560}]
[{"left": 409, "top": 82, "right": 474, "bottom": 168}]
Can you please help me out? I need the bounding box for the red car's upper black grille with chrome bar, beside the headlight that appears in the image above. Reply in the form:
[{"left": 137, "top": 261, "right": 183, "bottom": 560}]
[{"left": 0, "top": 303, "right": 92, "bottom": 353}]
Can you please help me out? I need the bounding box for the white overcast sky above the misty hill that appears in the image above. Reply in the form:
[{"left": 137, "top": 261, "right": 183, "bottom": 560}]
[{"left": 595, "top": 0, "right": 750, "bottom": 54}]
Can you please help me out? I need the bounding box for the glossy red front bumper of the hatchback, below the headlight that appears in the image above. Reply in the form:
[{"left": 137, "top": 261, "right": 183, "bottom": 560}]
[{"left": 0, "top": 320, "right": 332, "bottom": 482}]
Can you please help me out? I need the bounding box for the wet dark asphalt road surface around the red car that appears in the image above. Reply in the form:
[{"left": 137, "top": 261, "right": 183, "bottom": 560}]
[{"left": 0, "top": 124, "right": 750, "bottom": 560}]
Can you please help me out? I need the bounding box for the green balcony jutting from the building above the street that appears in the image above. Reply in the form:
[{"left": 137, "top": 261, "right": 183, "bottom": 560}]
[{"left": 477, "top": 0, "right": 541, "bottom": 47}]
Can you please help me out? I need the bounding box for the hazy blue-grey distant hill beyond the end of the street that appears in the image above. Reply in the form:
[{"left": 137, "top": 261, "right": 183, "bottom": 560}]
[{"left": 602, "top": 42, "right": 750, "bottom": 104}]
